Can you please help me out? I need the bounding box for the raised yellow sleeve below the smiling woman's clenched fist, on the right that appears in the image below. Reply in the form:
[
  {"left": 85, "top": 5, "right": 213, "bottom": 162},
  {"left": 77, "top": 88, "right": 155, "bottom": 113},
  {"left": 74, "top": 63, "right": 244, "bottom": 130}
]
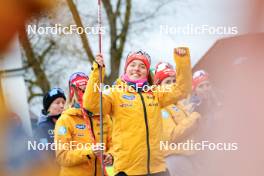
[{"left": 158, "top": 48, "right": 192, "bottom": 108}]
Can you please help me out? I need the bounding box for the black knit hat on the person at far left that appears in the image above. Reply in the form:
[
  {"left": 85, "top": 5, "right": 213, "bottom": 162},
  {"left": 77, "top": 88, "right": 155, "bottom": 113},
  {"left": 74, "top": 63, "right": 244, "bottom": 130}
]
[{"left": 42, "top": 88, "right": 66, "bottom": 115}]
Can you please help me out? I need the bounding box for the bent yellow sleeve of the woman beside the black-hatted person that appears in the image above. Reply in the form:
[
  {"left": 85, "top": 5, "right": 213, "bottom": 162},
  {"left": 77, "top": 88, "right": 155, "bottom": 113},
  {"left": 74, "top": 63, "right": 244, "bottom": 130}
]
[{"left": 54, "top": 115, "right": 94, "bottom": 167}]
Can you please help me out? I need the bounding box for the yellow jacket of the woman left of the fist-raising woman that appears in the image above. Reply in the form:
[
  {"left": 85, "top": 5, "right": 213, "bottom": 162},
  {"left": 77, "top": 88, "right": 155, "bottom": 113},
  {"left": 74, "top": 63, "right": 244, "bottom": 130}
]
[{"left": 55, "top": 108, "right": 112, "bottom": 176}]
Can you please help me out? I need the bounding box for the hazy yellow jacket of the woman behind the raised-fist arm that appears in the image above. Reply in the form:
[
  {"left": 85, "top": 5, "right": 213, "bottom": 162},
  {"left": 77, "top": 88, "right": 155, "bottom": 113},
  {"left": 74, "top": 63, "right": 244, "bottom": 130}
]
[{"left": 162, "top": 104, "right": 200, "bottom": 156}]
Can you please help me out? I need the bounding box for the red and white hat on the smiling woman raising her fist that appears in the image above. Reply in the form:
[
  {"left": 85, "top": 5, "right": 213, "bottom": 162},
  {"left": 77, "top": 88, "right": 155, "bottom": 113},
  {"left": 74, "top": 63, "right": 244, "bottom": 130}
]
[{"left": 125, "top": 50, "right": 151, "bottom": 72}]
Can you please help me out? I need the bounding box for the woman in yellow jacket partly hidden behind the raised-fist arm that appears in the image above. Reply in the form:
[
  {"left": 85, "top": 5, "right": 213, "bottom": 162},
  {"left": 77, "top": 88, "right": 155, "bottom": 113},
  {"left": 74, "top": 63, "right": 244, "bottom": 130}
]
[{"left": 154, "top": 62, "right": 200, "bottom": 176}]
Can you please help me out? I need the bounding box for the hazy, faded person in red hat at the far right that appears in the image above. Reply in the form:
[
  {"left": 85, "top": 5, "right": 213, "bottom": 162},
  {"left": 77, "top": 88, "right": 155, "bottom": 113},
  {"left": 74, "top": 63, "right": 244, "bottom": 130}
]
[{"left": 181, "top": 70, "right": 222, "bottom": 175}]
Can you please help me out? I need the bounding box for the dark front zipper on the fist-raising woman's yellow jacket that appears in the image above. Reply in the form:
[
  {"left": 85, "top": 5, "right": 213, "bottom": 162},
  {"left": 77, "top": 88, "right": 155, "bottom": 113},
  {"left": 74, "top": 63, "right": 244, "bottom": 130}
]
[{"left": 138, "top": 92, "right": 150, "bottom": 175}]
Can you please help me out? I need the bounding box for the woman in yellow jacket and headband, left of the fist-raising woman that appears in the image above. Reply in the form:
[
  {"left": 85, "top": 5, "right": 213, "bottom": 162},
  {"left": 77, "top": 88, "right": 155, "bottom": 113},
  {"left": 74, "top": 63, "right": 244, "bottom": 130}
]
[{"left": 55, "top": 72, "right": 113, "bottom": 176}]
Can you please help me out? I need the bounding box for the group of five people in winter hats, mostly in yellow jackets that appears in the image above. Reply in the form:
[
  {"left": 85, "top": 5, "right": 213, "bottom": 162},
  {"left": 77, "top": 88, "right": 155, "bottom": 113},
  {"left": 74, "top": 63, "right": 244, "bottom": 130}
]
[{"left": 34, "top": 47, "right": 219, "bottom": 176}]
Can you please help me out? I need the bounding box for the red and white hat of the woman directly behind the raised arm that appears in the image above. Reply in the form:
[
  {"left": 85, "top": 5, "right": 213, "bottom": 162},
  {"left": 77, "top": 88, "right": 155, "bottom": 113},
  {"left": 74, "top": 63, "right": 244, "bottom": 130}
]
[{"left": 154, "top": 62, "right": 176, "bottom": 85}]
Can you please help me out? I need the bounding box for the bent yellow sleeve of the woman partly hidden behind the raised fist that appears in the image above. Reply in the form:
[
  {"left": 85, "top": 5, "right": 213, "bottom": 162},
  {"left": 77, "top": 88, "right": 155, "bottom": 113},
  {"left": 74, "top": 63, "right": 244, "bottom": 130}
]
[{"left": 171, "top": 109, "right": 200, "bottom": 142}]
